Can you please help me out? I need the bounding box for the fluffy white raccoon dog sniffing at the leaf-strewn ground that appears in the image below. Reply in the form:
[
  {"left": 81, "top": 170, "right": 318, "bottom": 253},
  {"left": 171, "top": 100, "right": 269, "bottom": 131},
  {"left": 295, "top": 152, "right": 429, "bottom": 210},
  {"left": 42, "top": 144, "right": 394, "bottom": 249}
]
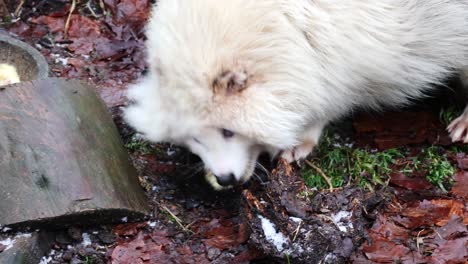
[{"left": 124, "top": 0, "right": 468, "bottom": 190}]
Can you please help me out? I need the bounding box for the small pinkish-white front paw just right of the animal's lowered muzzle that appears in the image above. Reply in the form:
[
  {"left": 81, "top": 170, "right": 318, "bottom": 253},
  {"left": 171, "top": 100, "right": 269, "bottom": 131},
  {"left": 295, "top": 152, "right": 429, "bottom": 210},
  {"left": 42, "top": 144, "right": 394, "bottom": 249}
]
[{"left": 281, "top": 123, "right": 325, "bottom": 162}]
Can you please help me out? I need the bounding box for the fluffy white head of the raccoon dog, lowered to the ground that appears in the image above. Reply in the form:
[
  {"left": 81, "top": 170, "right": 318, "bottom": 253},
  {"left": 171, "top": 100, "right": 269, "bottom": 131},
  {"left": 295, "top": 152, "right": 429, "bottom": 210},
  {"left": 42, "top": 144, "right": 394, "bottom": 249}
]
[{"left": 125, "top": 0, "right": 334, "bottom": 189}]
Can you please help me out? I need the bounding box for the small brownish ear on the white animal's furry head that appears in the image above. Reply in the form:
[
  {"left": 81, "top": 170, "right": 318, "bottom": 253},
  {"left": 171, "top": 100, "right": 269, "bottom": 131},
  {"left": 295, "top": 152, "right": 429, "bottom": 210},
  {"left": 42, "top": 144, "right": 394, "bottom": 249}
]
[{"left": 212, "top": 70, "right": 249, "bottom": 95}]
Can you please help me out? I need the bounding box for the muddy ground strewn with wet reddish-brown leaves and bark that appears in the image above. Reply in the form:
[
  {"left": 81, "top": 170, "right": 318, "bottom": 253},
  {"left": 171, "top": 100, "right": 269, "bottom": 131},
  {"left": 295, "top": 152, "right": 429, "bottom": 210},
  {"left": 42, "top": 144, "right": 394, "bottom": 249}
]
[{"left": 0, "top": 0, "right": 468, "bottom": 263}]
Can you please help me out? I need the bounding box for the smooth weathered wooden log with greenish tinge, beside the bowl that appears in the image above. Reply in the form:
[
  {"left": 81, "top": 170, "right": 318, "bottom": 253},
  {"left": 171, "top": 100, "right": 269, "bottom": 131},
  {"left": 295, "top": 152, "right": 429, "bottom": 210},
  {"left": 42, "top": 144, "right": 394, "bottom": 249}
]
[{"left": 0, "top": 79, "right": 148, "bottom": 227}]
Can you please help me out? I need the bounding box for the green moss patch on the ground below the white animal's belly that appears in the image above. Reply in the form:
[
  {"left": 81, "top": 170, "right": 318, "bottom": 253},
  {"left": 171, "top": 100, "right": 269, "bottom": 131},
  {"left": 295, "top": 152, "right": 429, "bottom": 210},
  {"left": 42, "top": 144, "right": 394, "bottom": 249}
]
[{"left": 302, "top": 137, "right": 455, "bottom": 191}]
